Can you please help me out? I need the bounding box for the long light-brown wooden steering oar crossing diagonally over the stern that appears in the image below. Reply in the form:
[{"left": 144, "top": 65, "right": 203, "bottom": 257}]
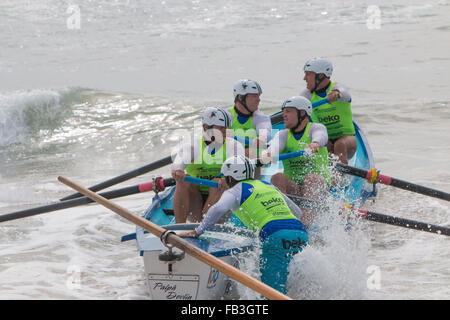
[{"left": 58, "top": 176, "right": 291, "bottom": 300}]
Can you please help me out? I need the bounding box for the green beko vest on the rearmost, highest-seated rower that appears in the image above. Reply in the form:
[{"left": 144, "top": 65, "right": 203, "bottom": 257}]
[{"left": 311, "top": 82, "right": 355, "bottom": 140}]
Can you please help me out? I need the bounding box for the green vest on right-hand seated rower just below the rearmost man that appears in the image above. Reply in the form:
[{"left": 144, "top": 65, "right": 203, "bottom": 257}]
[{"left": 282, "top": 122, "right": 331, "bottom": 184}]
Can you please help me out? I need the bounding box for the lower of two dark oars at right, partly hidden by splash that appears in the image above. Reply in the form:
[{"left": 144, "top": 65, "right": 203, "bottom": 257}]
[{"left": 287, "top": 194, "right": 450, "bottom": 236}]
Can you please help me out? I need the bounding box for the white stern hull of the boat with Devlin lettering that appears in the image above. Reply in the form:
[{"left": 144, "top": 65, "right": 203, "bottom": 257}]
[{"left": 136, "top": 224, "right": 254, "bottom": 300}]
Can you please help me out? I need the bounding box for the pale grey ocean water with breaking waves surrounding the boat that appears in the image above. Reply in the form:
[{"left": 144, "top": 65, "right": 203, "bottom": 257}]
[{"left": 0, "top": 0, "right": 450, "bottom": 300}]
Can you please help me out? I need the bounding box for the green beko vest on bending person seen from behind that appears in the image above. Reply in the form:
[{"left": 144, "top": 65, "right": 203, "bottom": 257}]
[{"left": 234, "top": 180, "right": 298, "bottom": 232}]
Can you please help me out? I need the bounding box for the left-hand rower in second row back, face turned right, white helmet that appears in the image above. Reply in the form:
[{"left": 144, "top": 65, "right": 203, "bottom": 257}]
[{"left": 227, "top": 79, "right": 272, "bottom": 158}]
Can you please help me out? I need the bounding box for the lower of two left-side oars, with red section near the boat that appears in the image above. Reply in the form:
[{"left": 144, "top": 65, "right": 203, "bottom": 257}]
[{"left": 0, "top": 178, "right": 175, "bottom": 222}]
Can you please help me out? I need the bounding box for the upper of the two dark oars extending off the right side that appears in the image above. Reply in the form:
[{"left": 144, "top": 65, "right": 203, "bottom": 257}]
[{"left": 335, "top": 163, "right": 450, "bottom": 201}]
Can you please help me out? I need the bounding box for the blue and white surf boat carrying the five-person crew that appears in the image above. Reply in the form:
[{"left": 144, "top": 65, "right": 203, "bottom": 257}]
[{"left": 123, "top": 112, "right": 376, "bottom": 300}]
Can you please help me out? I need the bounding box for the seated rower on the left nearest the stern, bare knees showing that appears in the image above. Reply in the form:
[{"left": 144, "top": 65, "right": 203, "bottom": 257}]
[{"left": 172, "top": 107, "right": 245, "bottom": 223}]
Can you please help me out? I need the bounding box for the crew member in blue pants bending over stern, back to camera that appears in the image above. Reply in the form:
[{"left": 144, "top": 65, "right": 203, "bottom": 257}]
[{"left": 179, "top": 156, "right": 308, "bottom": 293}]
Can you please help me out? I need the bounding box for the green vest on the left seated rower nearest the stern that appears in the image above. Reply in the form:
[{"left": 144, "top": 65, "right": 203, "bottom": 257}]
[{"left": 186, "top": 137, "right": 227, "bottom": 194}]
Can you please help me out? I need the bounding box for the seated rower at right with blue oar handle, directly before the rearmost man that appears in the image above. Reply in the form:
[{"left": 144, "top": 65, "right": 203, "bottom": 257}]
[{"left": 262, "top": 96, "right": 331, "bottom": 227}]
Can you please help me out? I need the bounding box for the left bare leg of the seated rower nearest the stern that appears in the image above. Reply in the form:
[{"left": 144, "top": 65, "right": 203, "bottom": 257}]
[{"left": 173, "top": 181, "right": 202, "bottom": 223}]
